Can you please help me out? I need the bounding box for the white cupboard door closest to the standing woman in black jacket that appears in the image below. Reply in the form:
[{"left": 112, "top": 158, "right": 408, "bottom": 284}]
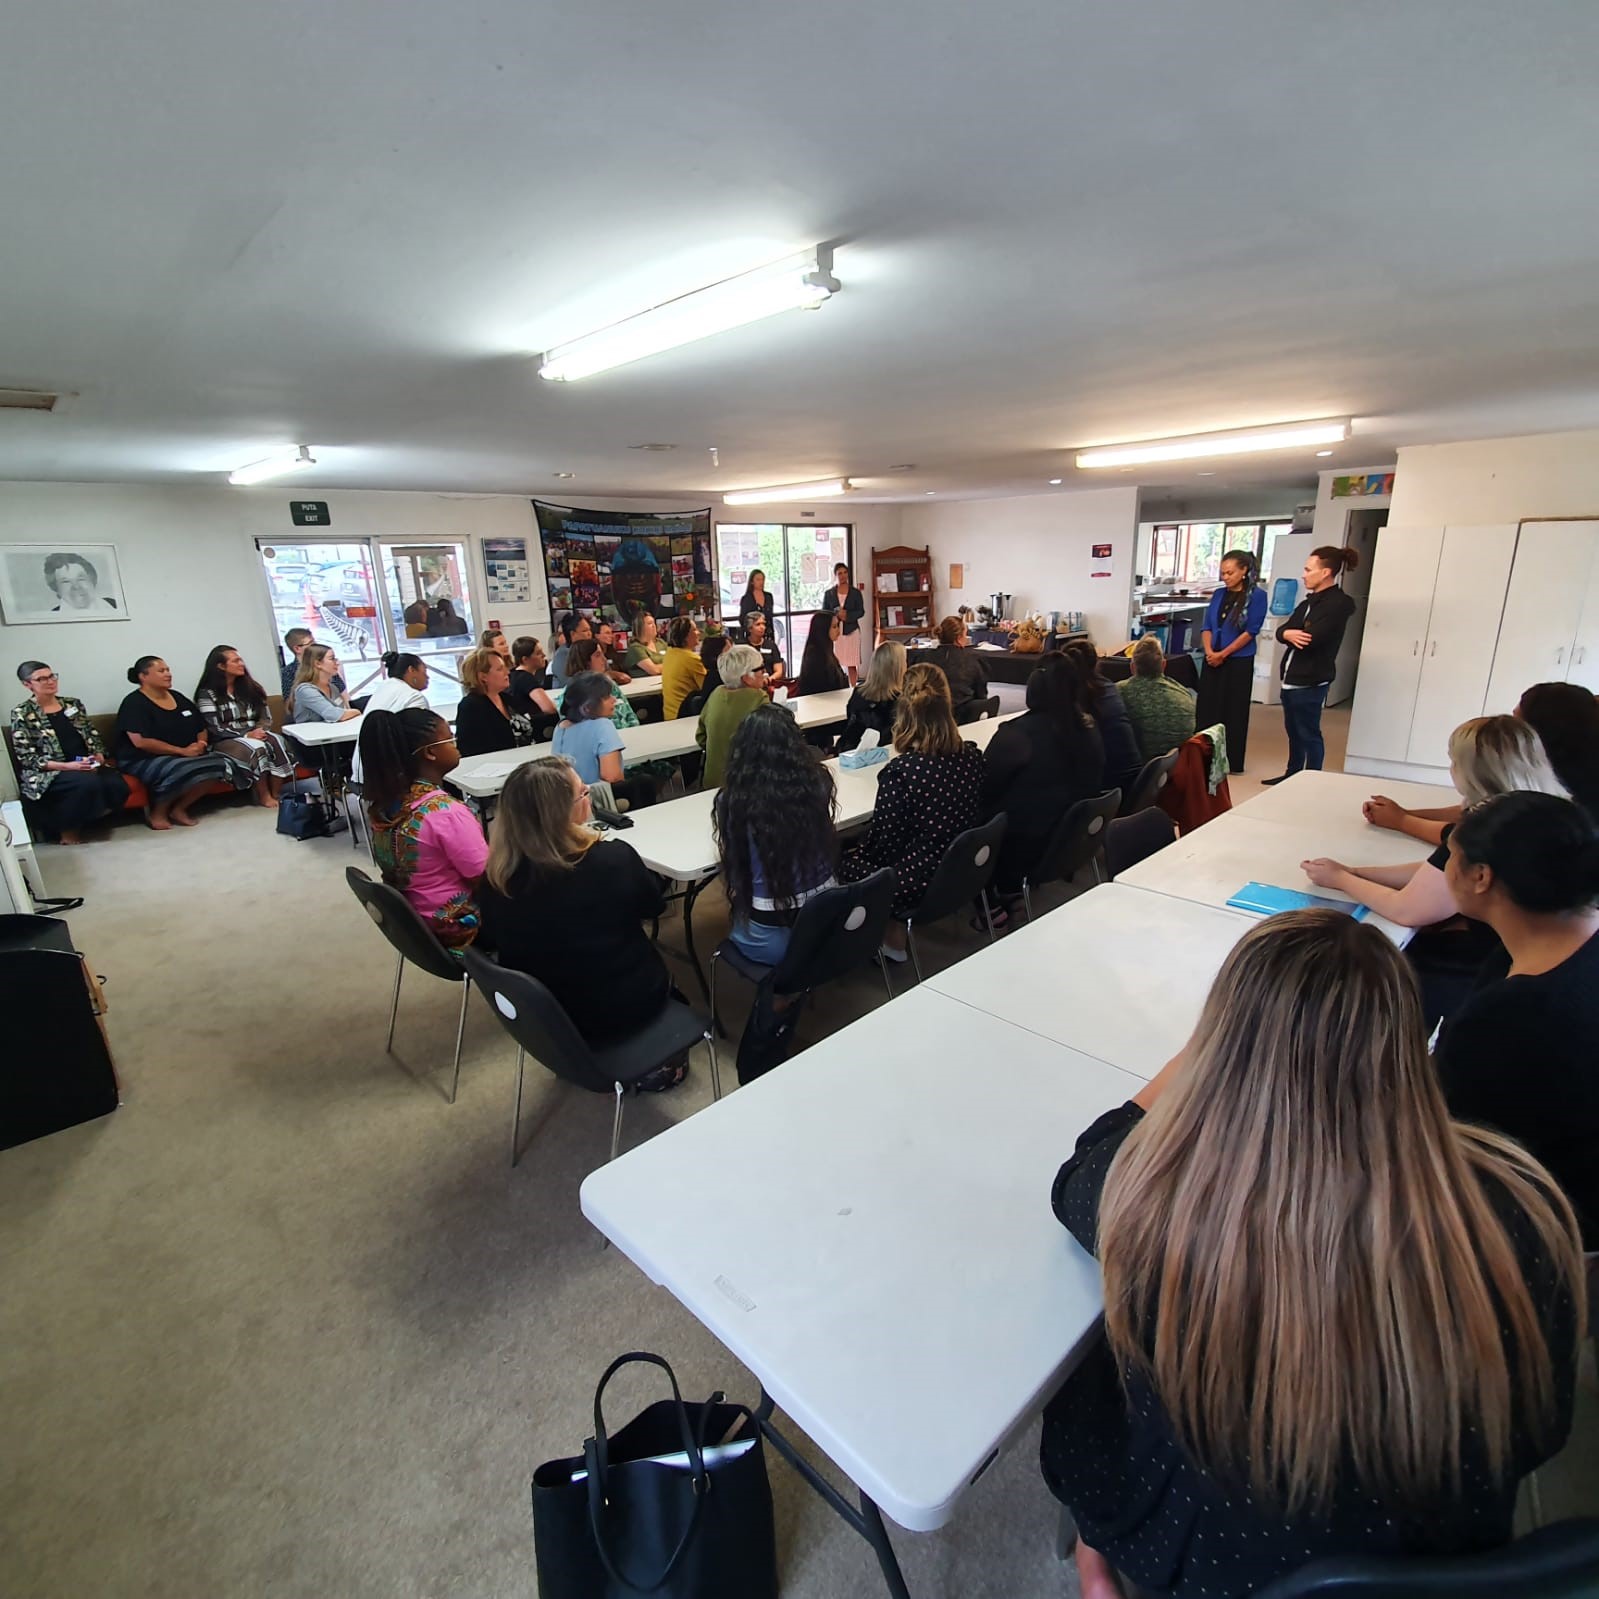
[{"left": 1348, "top": 524, "right": 1444, "bottom": 761}]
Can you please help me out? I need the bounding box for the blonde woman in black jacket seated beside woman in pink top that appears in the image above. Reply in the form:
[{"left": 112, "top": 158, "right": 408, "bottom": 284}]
[{"left": 466, "top": 755, "right": 683, "bottom": 1087}]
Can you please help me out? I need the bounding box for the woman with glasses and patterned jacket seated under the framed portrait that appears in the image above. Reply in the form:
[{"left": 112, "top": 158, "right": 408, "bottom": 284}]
[{"left": 11, "top": 660, "right": 128, "bottom": 844}]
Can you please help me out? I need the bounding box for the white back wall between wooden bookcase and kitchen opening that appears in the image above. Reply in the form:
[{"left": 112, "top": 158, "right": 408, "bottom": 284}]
[{"left": 895, "top": 484, "right": 1138, "bottom": 649}]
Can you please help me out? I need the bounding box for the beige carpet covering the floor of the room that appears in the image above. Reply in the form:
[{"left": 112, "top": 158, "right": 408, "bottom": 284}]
[{"left": 0, "top": 706, "right": 1593, "bottom": 1599}]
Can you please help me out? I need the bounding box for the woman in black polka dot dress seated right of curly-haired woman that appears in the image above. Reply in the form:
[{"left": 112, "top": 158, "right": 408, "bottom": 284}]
[{"left": 838, "top": 665, "right": 983, "bottom": 961}]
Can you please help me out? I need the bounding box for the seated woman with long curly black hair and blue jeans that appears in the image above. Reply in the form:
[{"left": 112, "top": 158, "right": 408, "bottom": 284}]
[{"left": 712, "top": 705, "right": 838, "bottom": 1083}]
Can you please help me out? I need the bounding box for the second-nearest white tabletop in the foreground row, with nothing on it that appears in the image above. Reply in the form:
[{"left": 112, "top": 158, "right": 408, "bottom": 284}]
[{"left": 927, "top": 879, "right": 1258, "bottom": 1079}]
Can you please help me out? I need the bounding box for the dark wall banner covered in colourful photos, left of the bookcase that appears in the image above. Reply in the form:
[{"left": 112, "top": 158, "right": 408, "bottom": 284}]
[{"left": 532, "top": 500, "right": 715, "bottom": 630}]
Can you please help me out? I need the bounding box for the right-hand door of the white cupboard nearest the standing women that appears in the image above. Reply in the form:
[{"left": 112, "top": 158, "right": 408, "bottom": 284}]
[{"left": 1406, "top": 523, "right": 1516, "bottom": 766}]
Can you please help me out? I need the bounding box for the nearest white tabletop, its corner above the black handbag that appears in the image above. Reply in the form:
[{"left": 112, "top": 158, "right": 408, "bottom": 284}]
[{"left": 582, "top": 988, "right": 1138, "bottom": 1532}]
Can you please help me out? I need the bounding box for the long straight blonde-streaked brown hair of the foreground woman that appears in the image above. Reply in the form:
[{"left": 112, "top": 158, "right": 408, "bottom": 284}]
[{"left": 1099, "top": 910, "right": 1583, "bottom": 1514}]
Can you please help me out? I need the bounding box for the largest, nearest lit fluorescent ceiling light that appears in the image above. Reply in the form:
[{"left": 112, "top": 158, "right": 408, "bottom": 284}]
[{"left": 539, "top": 245, "right": 841, "bottom": 384}]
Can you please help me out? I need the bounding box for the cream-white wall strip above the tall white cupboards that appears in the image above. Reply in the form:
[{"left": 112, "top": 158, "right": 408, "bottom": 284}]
[{"left": 1388, "top": 430, "right": 1599, "bottom": 526}]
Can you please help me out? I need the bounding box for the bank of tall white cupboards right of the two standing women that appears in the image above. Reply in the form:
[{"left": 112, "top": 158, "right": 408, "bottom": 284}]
[{"left": 1345, "top": 520, "right": 1599, "bottom": 777}]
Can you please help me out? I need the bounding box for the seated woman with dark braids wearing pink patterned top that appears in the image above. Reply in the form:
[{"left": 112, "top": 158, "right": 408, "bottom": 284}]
[{"left": 361, "top": 707, "right": 489, "bottom": 950}]
